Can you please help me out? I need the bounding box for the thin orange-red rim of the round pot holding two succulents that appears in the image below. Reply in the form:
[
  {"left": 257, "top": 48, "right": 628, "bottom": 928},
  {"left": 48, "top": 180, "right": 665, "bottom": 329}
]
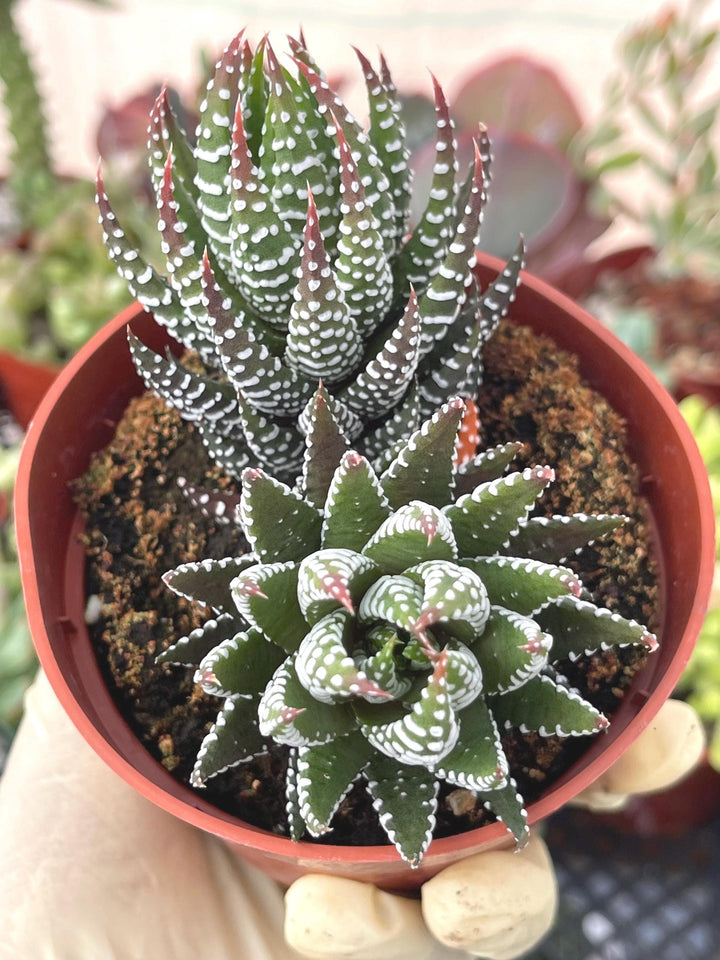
[{"left": 15, "top": 254, "right": 715, "bottom": 874}]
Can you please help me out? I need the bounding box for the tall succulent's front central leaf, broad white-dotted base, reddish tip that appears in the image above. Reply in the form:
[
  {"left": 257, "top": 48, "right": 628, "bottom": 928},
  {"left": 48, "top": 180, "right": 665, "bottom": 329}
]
[{"left": 285, "top": 193, "right": 363, "bottom": 383}]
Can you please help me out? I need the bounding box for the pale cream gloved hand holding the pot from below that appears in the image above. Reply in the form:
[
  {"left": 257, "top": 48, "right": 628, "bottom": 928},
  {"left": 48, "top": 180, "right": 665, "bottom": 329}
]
[{"left": 0, "top": 674, "right": 704, "bottom": 960}]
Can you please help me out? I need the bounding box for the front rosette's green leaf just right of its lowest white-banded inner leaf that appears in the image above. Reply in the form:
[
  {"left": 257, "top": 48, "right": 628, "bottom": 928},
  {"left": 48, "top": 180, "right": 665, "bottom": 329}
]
[{"left": 435, "top": 698, "right": 509, "bottom": 792}]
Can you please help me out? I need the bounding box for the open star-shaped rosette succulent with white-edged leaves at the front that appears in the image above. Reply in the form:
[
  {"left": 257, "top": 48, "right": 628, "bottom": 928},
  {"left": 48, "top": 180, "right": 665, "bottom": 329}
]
[{"left": 160, "top": 387, "right": 656, "bottom": 865}]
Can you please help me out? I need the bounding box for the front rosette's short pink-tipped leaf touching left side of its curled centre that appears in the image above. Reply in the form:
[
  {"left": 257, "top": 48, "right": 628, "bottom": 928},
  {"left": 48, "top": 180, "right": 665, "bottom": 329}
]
[{"left": 230, "top": 562, "right": 307, "bottom": 653}]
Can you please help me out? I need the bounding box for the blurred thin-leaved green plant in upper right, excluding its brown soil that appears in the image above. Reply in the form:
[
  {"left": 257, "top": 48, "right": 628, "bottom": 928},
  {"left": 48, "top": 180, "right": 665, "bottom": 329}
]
[{"left": 571, "top": 0, "right": 720, "bottom": 278}]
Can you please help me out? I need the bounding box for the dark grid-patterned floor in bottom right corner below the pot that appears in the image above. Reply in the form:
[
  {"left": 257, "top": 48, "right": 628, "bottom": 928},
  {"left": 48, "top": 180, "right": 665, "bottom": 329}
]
[{"left": 527, "top": 811, "right": 720, "bottom": 960}]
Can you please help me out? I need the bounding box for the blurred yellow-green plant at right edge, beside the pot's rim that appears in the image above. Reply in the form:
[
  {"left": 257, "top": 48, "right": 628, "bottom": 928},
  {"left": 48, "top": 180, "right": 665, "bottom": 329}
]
[{"left": 678, "top": 396, "right": 720, "bottom": 771}]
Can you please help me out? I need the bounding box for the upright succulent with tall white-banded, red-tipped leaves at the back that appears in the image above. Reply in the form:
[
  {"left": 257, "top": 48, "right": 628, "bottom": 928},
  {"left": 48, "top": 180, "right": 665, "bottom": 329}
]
[{"left": 98, "top": 34, "right": 523, "bottom": 479}]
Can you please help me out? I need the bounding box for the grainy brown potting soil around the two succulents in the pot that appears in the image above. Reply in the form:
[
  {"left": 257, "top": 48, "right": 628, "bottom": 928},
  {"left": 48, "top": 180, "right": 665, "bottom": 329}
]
[{"left": 76, "top": 324, "right": 657, "bottom": 845}]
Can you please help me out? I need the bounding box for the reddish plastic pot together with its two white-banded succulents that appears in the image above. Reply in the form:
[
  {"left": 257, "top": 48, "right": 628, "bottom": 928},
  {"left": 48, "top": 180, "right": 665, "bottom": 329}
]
[{"left": 17, "top": 28, "right": 713, "bottom": 888}]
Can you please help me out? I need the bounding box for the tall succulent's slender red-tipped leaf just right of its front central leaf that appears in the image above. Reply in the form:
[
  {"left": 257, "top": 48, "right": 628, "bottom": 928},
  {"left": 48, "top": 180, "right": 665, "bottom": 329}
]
[{"left": 333, "top": 117, "right": 393, "bottom": 337}]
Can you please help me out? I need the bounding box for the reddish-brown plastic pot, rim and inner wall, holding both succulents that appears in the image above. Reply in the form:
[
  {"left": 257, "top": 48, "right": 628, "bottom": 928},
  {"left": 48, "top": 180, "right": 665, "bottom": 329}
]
[{"left": 16, "top": 256, "right": 715, "bottom": 889}]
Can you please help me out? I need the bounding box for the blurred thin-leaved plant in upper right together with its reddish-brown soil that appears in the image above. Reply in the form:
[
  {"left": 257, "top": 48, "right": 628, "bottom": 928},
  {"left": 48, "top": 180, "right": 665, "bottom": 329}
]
[{"left": 570, "top": 0, "right": 720, "bottom": 403}]
